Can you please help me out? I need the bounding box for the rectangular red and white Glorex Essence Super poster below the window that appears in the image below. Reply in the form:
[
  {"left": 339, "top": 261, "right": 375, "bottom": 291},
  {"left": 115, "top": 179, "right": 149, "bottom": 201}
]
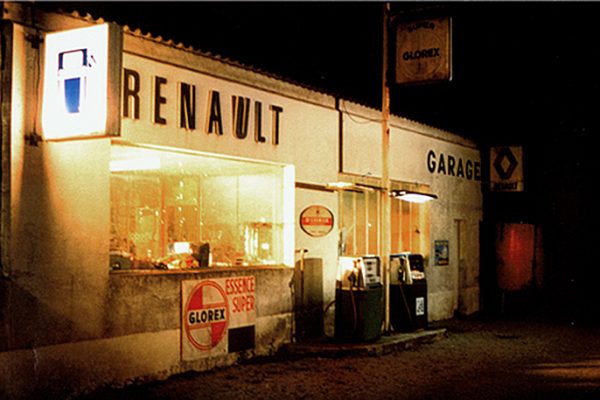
[{"left": 181, "top": 276, "right": 256, "bottom": 361}]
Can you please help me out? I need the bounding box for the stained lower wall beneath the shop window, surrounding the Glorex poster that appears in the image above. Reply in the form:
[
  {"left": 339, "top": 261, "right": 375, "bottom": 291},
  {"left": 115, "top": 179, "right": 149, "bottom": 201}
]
[{"left": 0, "top": 268, "right": 293, "bottom": 399}]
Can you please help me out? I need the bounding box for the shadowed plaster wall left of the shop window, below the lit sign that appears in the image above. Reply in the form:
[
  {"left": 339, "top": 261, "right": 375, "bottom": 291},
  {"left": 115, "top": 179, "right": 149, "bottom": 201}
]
[{"left": 10, "top": 21, "right": 110, "bottom": 340}]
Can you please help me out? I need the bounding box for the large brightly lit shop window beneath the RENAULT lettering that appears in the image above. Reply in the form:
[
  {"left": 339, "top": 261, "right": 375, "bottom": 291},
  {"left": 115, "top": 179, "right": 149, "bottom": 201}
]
[{"left": 110, "top": 145, "right": 293, "bottom": 269}]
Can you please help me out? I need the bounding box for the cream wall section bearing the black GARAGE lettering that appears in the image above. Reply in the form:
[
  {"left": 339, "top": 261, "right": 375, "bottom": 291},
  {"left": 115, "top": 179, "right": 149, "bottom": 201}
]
[{"left": 341, "top": 102, "right": 482, "bottom": 320}]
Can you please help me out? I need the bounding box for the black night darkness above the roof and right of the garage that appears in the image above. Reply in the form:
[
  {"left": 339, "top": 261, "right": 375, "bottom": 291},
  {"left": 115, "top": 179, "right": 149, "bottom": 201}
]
[{"left": 37, "top": 2, "right": 600, "bottom": 323}]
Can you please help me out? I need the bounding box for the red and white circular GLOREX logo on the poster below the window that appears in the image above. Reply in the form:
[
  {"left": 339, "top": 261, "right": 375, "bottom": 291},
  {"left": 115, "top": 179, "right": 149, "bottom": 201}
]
[{"left": 184, "top": 281, "right": 229, "bottom": 350}]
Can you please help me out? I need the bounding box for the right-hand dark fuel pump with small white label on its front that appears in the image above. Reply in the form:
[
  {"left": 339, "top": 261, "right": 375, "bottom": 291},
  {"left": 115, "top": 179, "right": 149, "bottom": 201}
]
[{"left": 390, "top": 253, "right": 427, "bottom": 332}]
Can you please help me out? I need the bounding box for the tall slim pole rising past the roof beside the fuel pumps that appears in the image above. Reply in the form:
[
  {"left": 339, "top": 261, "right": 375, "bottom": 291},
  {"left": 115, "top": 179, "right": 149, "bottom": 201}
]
[{"left": 381, "top": 3, "right": 391, "bottom": 333}]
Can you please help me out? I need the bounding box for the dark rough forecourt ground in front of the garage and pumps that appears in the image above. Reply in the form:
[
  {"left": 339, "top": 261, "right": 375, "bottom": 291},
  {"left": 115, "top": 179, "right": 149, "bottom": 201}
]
[{"left": 77, "top": 320, "right": 600, "bottom": 400}]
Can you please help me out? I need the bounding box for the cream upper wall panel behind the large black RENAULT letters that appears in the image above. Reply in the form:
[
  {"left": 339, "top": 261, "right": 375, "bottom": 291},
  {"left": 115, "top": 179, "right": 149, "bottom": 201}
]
[{"left": 121, "top": 54, "right": 338, "bottom": 187}]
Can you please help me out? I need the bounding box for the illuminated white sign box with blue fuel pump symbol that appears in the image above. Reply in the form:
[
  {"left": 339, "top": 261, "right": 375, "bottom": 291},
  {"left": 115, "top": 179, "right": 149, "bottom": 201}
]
[{"left": 42, "top": 23, "right": 122, "bottom": 140}]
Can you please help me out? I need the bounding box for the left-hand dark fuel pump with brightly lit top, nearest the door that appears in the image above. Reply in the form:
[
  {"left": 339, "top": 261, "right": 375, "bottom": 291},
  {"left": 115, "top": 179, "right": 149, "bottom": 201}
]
[{"left": 335, "top": 256, "right": 383, "bottom": 341}]
